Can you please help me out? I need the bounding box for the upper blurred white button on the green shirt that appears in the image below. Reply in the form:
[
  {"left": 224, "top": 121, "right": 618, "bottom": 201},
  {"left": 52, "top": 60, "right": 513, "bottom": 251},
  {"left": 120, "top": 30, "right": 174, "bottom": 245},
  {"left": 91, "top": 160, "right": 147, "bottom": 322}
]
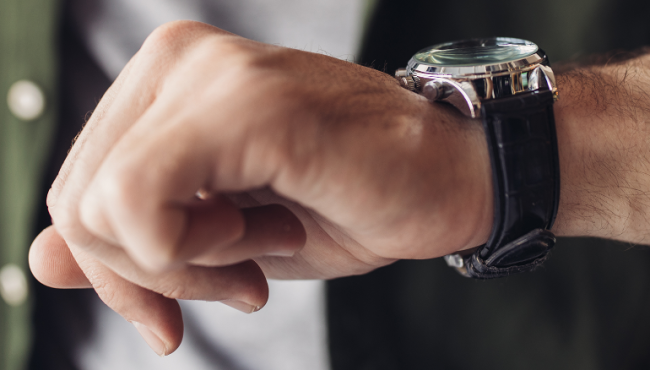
[{"left": 7, "top": 80, "right": 45, "bottom": 121}]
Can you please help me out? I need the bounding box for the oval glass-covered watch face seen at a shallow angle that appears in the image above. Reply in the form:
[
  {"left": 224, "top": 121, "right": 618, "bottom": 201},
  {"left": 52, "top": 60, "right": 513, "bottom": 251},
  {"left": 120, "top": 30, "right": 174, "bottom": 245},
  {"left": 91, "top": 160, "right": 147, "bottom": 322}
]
[{"left": 413, "top": 37, "right": 539, "bottom": 67}]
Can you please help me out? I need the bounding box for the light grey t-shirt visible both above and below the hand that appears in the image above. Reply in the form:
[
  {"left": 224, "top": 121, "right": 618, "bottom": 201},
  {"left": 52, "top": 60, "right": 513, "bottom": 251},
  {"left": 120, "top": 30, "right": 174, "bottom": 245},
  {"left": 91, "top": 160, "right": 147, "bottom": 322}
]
[{"left": 71, "top": 0, "right": 365, "bottom": 370}]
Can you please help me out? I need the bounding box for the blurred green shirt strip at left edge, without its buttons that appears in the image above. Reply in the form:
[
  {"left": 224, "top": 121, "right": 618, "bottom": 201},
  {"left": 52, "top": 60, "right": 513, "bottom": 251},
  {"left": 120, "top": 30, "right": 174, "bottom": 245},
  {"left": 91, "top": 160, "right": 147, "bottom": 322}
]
[{"left": 0, "top": 0, "right": 59, "bottom": 370}]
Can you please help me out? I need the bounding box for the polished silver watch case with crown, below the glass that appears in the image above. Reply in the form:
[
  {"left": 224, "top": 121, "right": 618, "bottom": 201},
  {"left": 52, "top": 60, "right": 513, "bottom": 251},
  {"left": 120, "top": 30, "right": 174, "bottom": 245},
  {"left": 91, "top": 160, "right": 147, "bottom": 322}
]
[{"left": 395, "top": 43, "right": 558, "bottom": 118}]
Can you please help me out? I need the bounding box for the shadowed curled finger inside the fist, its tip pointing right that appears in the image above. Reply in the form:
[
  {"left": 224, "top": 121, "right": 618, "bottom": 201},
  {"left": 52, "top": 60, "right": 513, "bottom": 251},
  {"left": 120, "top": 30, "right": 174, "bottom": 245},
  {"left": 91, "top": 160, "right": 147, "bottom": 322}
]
[{"left": 191, "top": 204, "right": 307, "bottom": 266}]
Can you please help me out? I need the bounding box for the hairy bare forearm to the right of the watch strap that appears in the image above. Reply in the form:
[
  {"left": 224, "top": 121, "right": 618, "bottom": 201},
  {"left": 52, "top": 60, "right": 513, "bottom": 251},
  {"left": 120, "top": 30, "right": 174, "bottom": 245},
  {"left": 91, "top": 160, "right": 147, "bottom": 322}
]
[{"left": 554, "top": 51, "right": 650, "bottom": 243}]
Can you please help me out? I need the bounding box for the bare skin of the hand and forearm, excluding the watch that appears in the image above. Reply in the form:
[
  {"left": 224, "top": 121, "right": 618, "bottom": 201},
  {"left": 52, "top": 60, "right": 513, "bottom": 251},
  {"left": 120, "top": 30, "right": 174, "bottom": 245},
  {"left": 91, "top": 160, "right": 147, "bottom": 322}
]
[{"left": 30, "top": 21, "right": 650, "bottom": 355}]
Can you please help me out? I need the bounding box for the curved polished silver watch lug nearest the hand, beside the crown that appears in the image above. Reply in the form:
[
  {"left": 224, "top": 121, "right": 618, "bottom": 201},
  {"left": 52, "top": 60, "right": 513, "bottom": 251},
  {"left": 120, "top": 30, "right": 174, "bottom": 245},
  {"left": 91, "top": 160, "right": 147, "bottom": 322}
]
[{"left": 425, "top": 78, "right": 481, "bottom": 118}]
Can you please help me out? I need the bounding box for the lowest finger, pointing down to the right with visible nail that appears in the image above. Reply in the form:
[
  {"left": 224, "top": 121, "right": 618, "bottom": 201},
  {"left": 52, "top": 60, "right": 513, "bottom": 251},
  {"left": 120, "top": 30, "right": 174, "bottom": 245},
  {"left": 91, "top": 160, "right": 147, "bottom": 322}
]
[{"left": 67, "top": 244, "right": 183, "bottom": 356}]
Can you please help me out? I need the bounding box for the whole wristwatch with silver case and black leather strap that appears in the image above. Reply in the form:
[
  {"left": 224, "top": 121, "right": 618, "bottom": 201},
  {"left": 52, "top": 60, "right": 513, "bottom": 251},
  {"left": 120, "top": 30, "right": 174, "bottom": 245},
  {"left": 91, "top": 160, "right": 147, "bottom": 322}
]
[{"left": 395, "top": 37, "right": 560, "bottom": 279}]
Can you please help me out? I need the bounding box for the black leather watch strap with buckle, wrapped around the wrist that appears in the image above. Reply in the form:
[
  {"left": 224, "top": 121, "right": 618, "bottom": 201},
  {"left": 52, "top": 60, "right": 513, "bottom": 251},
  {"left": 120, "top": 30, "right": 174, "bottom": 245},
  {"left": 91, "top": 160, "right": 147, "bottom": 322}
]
[{"left": 457, "top": 91, "right": 560, "bottom": 279}]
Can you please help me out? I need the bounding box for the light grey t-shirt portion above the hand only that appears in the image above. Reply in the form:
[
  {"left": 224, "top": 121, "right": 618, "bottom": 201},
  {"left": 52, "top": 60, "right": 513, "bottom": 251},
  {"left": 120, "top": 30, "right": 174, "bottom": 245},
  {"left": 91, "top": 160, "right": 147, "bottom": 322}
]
[{"left": 72, "top": 0, "right": 366, "bottom": 77}]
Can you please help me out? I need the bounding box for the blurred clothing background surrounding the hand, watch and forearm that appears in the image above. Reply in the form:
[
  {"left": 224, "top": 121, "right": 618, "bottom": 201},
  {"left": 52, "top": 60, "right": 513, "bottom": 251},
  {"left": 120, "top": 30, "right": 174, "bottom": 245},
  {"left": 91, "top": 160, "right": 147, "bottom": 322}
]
[{"left": 0, "top": 0, "right": 650, "bottom": 370}]
